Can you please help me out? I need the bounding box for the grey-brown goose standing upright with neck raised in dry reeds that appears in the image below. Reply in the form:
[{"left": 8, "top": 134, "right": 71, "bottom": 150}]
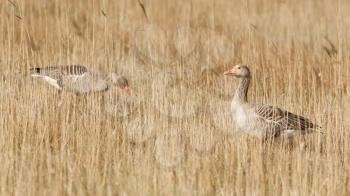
[{"left": 224, "top": 65, "right": 318, "bottom": 139}]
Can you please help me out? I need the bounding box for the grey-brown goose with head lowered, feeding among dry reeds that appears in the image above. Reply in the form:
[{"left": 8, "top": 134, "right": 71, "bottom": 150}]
[{"left": 30, "top": 65, "right": 131, "bottom": 95}]
